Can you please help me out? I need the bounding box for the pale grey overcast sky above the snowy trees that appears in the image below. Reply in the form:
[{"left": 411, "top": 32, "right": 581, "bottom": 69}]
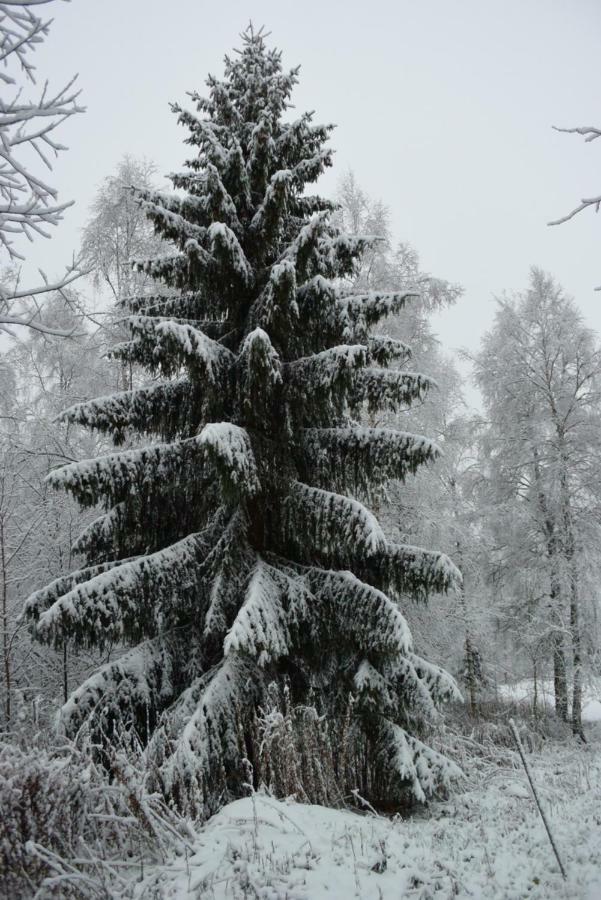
[{"left": 22, "top": 0, "right": 601, "bottom": 366}]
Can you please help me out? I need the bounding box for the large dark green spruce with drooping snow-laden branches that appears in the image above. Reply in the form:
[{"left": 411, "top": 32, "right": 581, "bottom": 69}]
[{"left": 22, "top": 29, "right": 459, "bottom": 815}]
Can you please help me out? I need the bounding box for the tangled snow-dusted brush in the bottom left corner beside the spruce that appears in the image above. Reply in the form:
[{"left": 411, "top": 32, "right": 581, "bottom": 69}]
[{"left": 0, "top": 742, "right": 190, "bottom": 900}]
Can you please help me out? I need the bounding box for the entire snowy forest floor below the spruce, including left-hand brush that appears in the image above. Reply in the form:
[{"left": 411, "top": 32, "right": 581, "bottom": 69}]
[{"left": 5, "top": 704, "right": 601, "bottom": 900}]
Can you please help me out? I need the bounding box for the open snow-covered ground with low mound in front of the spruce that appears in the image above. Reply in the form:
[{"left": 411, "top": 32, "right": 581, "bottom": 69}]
[{"left": 136, "top": 725, "right": 601, "bottom": 900}]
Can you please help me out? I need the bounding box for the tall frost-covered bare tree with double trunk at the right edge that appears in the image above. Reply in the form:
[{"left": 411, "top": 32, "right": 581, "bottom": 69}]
[{"left": 476, "top": 269, "right": 601, "bottom": 735}]
